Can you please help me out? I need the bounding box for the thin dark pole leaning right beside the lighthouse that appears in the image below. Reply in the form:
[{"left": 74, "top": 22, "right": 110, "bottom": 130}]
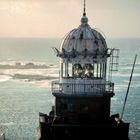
[{"left": 121, "top": 55, "right": 137, "bottom": 119}]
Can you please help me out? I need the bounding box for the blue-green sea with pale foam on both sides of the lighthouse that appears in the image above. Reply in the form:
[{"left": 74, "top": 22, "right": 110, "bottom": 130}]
[{"left": 0, "top": 38, "right": 140, "bottom": 140}]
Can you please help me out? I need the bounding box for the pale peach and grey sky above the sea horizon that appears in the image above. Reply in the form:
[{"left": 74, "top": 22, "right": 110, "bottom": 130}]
[{"left": 0, "top": 0, "right": 140, "bottom": 38}]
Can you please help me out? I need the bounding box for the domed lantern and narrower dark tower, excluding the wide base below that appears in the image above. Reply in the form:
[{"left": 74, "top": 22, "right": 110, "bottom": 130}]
[{"left": 52, "top": 2, "right": 118, "bottom": 124}]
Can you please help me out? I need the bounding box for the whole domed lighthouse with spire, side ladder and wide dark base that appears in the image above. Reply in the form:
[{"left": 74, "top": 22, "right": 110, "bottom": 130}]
[{"left": 37, "top": 1, "right": 129, "bottom": 140}]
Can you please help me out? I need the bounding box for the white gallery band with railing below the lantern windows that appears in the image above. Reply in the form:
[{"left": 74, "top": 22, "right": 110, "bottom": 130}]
[{"left": 52, "top": 81, "right": 114, "bottom": 94}]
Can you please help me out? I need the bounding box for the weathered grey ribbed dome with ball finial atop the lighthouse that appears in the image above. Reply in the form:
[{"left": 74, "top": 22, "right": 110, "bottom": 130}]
[{"left": 60, "top": 14, "right": 107, "bottom": 58}]
